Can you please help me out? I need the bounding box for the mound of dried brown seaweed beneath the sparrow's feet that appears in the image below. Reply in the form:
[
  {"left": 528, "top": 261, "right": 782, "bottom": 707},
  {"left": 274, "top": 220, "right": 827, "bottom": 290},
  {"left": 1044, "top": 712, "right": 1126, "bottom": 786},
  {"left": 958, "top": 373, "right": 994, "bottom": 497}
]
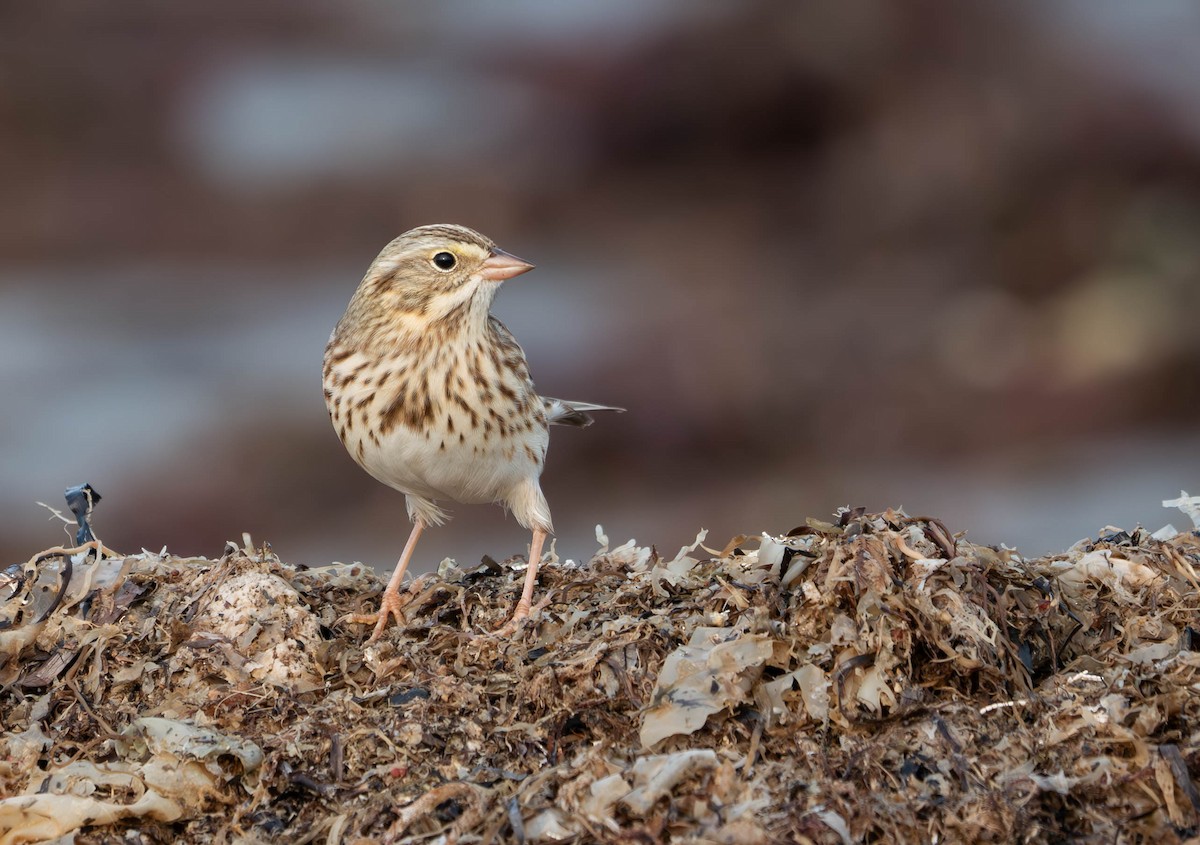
[{"left": 0, "top": 501, "right": 1200, "bottom": 845}]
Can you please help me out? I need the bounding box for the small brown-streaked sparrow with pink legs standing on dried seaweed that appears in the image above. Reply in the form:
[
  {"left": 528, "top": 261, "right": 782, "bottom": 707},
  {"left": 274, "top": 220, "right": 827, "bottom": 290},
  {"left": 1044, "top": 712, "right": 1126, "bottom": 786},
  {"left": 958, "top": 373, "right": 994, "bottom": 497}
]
[{"left": 323, "top": 224, "right": 624, "bottom": 643}]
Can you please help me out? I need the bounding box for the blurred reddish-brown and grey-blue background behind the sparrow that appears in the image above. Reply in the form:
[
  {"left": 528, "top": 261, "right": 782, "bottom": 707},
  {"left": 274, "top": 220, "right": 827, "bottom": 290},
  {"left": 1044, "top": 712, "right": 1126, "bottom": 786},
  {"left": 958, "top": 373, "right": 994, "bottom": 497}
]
[{"left": 0, "top": 0, "right": 1200, "bottom": 569}]
